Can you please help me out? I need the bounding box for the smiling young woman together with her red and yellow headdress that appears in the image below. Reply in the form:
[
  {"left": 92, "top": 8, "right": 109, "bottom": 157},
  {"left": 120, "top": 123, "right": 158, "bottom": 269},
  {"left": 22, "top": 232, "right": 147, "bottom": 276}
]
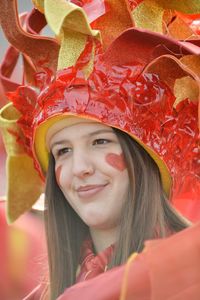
[{"left": 1, "top": 0, "right": 198, "bottom": 300}]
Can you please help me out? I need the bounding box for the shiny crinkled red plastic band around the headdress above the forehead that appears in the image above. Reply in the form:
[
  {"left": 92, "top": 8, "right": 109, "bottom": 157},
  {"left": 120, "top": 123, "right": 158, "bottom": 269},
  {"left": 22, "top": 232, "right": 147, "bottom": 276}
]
[{"left": 9, "top": 59, "right": 200, "bottom": 204}]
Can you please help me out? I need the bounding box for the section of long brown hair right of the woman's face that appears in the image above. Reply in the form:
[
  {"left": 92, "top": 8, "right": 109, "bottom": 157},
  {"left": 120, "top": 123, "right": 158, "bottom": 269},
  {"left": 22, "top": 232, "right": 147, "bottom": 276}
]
[{"left": 110, "top": 129, "right": 189, "bottom": 267}]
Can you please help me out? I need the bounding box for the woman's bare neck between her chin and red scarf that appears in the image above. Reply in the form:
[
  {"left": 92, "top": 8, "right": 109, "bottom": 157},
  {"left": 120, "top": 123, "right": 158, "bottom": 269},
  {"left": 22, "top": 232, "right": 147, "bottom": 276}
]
[{"left": 90, "top": 227, "right": 118, "bottom": 253}]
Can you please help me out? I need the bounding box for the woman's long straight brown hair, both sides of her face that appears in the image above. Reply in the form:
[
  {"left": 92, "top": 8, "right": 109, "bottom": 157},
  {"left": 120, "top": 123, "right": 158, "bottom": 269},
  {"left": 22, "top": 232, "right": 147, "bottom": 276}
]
[{"left": 45, "top": 129, "right": 187, "bottom": 300}]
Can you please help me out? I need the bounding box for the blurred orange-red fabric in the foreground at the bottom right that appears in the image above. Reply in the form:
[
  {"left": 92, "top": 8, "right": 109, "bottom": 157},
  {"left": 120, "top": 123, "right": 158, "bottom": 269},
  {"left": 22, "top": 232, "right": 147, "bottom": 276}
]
[{"left": 58, "top": 223, "right": 200, "bottom": 300}]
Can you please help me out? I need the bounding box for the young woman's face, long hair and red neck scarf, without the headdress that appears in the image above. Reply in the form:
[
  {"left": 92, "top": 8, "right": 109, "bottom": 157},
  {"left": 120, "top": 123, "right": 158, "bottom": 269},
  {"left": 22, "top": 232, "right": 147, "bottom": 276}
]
[{"left": 46, "top": 117, "right": 187, "bottom": 296}]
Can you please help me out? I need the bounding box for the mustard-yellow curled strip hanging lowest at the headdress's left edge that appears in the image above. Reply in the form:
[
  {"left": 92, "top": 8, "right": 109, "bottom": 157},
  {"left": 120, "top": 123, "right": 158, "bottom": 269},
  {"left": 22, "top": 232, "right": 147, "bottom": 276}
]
[{"left": 0, "top": 103, "right": 43, "bottom": 223}]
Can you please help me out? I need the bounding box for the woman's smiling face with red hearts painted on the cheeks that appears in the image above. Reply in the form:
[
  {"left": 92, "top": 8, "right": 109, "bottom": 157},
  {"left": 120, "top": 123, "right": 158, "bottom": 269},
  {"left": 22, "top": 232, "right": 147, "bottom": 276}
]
[{"left": 49, "top": 119, "right": 129, "bottom": 229}]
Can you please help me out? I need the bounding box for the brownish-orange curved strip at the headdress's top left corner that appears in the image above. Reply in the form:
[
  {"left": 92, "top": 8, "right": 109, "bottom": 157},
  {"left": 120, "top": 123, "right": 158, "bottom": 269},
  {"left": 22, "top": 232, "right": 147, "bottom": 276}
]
[{"left": 0, "top": 0, "right": 59, "bottom": 71}]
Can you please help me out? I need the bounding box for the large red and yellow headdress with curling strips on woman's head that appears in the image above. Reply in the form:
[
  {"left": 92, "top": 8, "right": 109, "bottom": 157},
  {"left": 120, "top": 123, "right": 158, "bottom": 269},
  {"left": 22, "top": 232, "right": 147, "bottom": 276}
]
[{"left": 0, "top": 0, "right": 200, "bottom": 221}]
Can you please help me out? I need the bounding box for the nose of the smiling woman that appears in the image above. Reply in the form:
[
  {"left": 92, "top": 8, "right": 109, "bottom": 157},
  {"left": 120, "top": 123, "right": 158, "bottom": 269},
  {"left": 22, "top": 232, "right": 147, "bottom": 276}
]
[{"left": 72, "top": 151, "right": 94, "bottom": 178}]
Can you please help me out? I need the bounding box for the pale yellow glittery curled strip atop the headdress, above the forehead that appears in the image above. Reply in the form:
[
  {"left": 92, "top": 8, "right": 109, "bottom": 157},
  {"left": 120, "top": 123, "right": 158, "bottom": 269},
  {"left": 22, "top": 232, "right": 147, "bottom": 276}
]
[{"left": 44, "top": 0, "right": 100, "bottom": 69}]
